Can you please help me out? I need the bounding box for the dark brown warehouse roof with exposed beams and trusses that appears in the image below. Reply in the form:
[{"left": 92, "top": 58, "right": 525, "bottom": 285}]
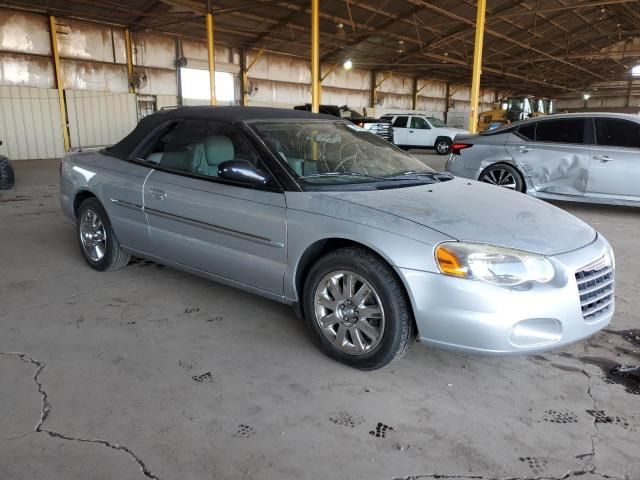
[{"left": 0, "top": 0, "right": 640, "bottom": 96}]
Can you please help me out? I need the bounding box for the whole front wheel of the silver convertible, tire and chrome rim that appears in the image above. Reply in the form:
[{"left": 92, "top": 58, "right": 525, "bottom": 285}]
[{"left": 303, "top": 247, "right": 416, "bottom": 370}]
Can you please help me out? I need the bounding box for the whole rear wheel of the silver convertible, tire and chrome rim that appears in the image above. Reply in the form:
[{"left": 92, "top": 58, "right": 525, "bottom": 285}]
[{"left": 76, "top": 197, "right": 131, "bottom": 272}]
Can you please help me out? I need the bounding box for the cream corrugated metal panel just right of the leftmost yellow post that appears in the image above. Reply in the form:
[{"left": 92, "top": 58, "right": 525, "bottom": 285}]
[{"left": 65, "top": 90, "right": 138, "bottom": 148}]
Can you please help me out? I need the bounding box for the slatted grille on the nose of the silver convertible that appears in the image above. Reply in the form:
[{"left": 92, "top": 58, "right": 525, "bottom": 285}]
[{"left": 576, "top": 257, "right": 614, "bottom": 322}]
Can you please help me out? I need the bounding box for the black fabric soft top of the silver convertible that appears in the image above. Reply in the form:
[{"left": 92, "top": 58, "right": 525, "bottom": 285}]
[{"left": 107, "top": 105, "right": 336, "bottom": 158}]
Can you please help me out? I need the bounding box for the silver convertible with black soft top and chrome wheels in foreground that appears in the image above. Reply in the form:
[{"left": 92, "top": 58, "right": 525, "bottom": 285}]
[{"left": 60, "top": 107, "right": 614, "bottom": 369}]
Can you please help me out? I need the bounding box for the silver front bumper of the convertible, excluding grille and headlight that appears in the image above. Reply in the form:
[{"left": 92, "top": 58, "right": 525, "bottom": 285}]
[{"left": 397, "top": 235, "right": 614, "bottom": 354}]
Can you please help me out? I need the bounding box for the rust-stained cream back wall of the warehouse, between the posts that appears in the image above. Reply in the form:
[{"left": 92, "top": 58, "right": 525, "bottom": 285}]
[{"left": 0, "top": 9, "right": 500, "bottom": 159}]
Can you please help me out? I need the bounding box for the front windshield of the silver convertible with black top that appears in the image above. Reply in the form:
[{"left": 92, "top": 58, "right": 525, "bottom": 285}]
[{"left": 252, "top": 120, "right": 434, "bottom": 185}]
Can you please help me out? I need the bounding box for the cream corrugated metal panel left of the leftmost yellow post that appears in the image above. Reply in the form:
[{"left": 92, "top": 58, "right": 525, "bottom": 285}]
[{"left": 0, "top": 86, "right": 64, "bottom": 159}]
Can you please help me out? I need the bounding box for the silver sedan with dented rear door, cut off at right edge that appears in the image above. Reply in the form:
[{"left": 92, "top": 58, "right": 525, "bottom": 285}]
[{"left": 446, "top": 113, "right": 640, "bottom": 205}]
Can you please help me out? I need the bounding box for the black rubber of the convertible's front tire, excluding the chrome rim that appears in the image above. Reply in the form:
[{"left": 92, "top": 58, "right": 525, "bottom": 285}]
[{"left": 303, "top": 247, "right": 416, "bottom": 370}]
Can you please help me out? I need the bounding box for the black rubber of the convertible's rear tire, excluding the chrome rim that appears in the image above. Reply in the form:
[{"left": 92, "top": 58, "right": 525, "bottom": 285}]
[{"left": 76, "top": 197, "right": 131, "bottom": 272}]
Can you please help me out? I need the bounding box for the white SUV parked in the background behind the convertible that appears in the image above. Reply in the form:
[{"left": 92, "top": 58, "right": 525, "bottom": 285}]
[{"left": 380, "top": 114, "right": 469, "bottom": 155}]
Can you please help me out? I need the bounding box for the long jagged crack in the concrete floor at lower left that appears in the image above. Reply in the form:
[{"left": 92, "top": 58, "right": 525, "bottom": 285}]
[{"left": 0, "top": 352, "right": 161, "bottom": 480}]
